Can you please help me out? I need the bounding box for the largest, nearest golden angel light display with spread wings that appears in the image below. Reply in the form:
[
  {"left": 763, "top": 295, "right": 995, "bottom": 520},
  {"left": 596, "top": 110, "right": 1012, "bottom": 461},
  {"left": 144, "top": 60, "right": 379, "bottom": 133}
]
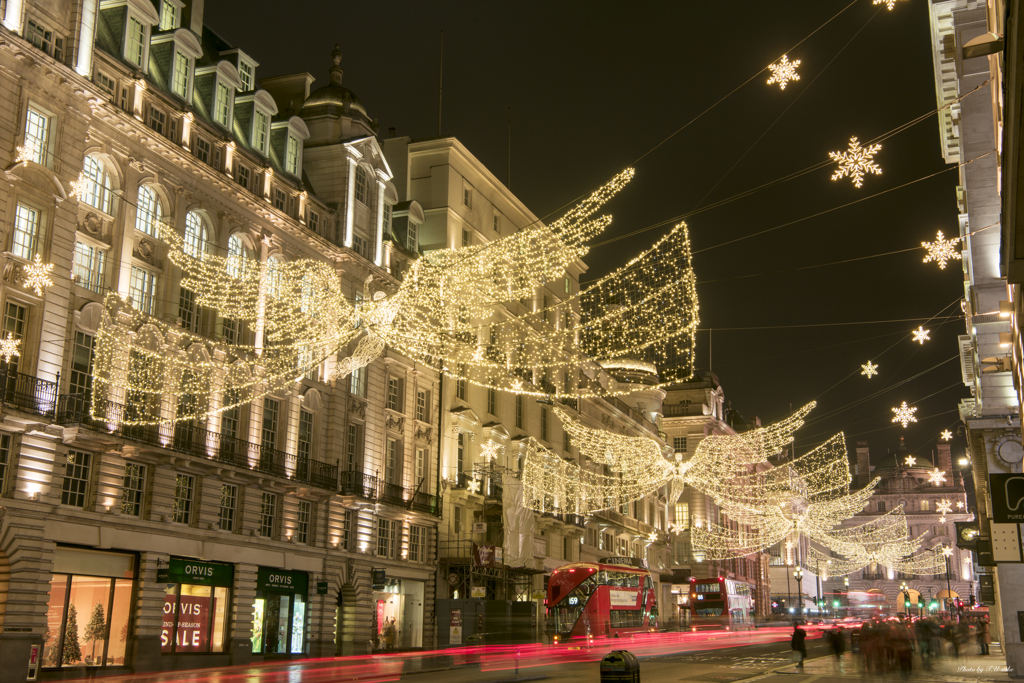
[{"left": 90, "top": 169, "right": 698, "bottom": 425}]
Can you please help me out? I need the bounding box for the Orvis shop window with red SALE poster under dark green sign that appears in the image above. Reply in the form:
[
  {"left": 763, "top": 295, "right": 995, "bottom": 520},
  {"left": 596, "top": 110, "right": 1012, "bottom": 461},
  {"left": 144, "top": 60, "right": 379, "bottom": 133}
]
[{"left": 157, "top": 557, "right": 234, "bottom": 654}]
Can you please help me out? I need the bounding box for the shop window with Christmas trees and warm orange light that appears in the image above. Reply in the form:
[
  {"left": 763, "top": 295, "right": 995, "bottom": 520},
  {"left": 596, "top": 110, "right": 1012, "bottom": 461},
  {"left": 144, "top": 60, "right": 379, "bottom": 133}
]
[{"left": 42, "top": 547, "right": 137, "bottom": 669}]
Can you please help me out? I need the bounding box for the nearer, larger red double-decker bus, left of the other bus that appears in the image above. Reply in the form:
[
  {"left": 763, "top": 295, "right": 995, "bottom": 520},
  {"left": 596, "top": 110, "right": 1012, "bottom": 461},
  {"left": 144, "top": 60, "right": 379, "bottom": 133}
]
[{"left": 548, "top": 557, "right": 657, "bottom": 641}]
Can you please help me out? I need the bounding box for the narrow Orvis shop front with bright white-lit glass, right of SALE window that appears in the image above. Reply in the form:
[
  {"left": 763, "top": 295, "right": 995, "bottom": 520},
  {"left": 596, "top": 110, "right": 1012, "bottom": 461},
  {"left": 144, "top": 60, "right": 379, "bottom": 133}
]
[{"left": 252, "top": 567, "right": 309, "bottom": 654}]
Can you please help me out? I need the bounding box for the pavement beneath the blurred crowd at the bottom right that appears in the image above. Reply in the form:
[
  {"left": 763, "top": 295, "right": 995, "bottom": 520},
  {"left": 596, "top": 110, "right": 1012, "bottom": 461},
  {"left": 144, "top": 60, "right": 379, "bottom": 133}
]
[{"left": 765, "top": 643, "right": 1009, "bottom": 683}]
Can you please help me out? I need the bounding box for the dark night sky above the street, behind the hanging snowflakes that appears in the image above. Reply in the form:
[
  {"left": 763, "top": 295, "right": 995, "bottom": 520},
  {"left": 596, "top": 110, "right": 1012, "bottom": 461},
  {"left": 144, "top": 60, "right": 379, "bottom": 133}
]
[{"left": 206, "top": 0, "right": 970, "bottom": 471}]
